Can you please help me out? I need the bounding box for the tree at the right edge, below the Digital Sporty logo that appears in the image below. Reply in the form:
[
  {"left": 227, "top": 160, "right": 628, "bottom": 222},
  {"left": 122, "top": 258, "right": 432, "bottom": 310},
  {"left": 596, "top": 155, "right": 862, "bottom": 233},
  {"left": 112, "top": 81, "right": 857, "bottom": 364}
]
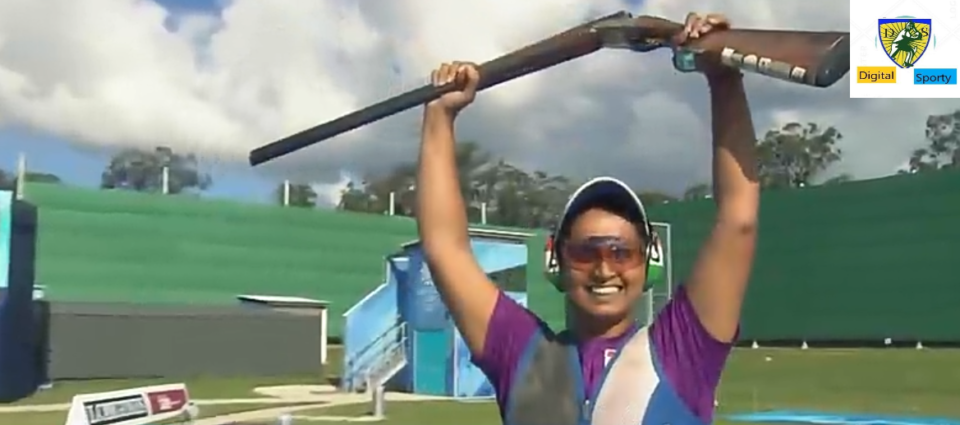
[{"left": 901, "top": 109, "right": 960, "bottom": 174}]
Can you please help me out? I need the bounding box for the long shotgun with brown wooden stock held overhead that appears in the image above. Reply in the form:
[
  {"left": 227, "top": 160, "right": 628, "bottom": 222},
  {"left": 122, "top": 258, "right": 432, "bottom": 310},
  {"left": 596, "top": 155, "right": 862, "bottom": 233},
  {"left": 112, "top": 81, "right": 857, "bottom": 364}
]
[{"left": 250, "top": 12, "right": 850, "bottom": 165}]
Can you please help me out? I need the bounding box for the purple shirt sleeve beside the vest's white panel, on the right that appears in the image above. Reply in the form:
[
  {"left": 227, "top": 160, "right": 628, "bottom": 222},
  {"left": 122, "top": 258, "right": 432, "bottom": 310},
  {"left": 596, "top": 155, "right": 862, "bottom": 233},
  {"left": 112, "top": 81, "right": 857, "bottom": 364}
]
[{"left": 650, "top": 285, "right": 736, "bottom": 423}]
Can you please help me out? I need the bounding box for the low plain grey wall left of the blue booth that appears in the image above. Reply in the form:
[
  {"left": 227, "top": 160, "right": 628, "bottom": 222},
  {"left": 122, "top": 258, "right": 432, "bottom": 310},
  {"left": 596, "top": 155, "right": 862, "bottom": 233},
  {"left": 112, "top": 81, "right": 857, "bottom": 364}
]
[{"left": 37, "top": 302, "right": 322, "bottom": 380}]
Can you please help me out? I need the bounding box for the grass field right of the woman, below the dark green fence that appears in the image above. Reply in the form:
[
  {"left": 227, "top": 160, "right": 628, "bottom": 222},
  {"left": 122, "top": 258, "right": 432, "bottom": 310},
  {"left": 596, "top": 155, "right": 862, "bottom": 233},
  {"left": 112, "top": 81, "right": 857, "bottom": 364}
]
[{"left": 719, "top": 349, "right": 960, "bottom": 418}]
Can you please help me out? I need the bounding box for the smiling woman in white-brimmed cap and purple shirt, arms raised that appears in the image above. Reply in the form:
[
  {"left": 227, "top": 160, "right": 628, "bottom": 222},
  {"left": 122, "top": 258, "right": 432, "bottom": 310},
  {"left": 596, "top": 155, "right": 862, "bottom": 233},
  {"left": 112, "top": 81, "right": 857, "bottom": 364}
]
[{"left": 417, "top": 14, "right": 759, "bottom": 425}]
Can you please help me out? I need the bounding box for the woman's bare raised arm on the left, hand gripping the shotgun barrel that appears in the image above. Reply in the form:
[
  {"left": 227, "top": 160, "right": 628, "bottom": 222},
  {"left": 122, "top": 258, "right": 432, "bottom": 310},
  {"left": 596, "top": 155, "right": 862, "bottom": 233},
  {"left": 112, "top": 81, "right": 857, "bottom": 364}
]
[{"left": 417, "top": 63, "right": 499, "bottom": 356}]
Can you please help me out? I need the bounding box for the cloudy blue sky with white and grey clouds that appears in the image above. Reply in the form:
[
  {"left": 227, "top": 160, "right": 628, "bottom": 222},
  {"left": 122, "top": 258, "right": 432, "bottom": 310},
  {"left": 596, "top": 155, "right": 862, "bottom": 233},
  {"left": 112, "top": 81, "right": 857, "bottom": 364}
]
[{"left": 0, "top": 0, "right": 960, "bottom": 205}]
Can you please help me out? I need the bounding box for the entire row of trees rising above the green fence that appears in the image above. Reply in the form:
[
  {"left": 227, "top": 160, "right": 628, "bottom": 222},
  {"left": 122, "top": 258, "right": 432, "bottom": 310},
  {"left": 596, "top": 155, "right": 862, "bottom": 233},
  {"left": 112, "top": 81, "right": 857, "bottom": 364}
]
[{"left": 0, "top": 109, "right": 960, "bottom": 227}]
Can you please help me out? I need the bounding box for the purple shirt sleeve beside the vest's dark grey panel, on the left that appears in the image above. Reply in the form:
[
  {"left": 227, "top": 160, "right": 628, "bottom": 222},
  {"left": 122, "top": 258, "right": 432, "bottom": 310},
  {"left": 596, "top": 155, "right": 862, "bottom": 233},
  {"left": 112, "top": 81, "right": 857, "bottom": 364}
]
[{"left": 472, "top": 292, "right": 545, "bottom": 413}]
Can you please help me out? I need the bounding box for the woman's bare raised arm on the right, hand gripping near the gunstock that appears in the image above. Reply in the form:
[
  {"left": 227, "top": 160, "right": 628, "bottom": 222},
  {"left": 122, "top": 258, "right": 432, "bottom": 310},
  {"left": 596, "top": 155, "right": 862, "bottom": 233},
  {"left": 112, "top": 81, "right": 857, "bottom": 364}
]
[{"left": 687, "top": 15, "right": 760, "bottom": 342}]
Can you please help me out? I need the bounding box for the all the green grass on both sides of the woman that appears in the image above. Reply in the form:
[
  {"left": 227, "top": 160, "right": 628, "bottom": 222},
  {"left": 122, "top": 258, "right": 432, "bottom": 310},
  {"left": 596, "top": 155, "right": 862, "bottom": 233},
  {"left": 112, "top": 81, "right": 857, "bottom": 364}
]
[{"left": 0, "top": 348, "right": 960, "bottom": 425}]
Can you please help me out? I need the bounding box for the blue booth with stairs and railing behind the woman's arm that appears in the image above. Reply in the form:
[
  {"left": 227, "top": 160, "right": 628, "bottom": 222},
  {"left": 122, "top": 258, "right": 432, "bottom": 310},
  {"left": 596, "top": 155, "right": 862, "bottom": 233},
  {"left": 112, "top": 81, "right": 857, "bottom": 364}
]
[{"left": 343, "top": 227, "right": 530, "bottom": 397}]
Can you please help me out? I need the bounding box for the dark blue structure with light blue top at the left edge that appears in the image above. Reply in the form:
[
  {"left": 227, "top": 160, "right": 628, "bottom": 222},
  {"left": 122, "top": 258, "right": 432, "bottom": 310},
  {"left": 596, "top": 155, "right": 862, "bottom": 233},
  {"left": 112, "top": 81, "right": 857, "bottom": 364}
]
[{"left": 0, "top": 191, "right": 46, "bottom": 402}]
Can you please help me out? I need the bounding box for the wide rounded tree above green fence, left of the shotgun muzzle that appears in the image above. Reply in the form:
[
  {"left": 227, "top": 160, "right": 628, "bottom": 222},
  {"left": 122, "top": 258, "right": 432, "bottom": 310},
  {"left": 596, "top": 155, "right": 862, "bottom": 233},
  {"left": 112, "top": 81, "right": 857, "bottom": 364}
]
[{"left": 100, "top": 147, "right": 213, "bottom": 194}]
